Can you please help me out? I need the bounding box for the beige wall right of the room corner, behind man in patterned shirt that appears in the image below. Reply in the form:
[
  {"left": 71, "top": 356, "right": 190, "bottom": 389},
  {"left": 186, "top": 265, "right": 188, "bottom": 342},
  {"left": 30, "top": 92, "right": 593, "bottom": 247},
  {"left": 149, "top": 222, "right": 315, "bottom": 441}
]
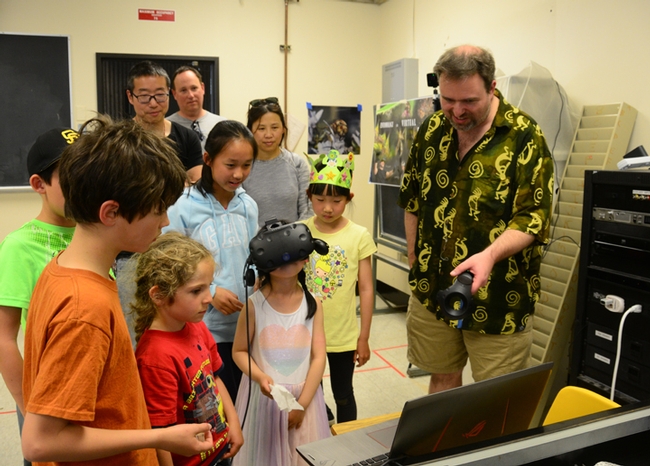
[{"left": 372, "top": 0, "right": 650, "bottom": 289}]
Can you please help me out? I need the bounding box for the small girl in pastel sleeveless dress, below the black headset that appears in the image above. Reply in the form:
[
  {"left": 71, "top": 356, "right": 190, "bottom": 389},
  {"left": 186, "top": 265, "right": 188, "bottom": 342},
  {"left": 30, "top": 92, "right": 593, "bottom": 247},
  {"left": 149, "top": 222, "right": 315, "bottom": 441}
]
[{"left": 233, "top": 226, "right": 330, "bottom": 466}]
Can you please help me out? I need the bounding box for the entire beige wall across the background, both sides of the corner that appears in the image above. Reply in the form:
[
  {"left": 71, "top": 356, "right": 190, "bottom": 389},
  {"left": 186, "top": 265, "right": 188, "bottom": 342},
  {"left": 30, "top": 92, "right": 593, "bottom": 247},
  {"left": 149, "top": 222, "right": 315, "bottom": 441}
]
[{"left": 0, "top": 0, "right": 650, "bottom": 289}]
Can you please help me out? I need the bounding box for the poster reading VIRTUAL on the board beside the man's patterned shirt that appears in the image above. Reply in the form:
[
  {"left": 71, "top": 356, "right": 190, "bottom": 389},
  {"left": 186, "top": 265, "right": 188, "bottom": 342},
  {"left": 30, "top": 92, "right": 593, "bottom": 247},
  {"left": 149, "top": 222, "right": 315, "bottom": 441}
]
[{"left": 370, "top": 97, "right": 433, "bottom": 186}]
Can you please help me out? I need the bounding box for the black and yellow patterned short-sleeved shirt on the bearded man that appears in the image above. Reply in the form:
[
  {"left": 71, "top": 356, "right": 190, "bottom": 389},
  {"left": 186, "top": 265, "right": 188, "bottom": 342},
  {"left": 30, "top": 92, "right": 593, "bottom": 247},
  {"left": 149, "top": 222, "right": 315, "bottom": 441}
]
[{"left": 398, "top": 90, "right": 553, "bottom": 334}]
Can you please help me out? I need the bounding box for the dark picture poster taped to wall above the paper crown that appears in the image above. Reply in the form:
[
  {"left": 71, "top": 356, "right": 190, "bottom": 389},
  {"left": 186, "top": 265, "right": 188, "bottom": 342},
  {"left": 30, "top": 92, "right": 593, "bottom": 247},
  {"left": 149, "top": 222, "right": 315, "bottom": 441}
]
[{"left": 307, "top": 103, "right": 361, "bottom": 154}]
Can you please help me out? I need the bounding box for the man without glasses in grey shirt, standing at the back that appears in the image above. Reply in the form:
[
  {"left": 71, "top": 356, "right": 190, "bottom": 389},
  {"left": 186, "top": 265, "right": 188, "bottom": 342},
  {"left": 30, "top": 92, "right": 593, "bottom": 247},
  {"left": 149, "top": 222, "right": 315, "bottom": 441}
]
[{"left": 167, "top": 65, "right": 225, "bottom": 151}]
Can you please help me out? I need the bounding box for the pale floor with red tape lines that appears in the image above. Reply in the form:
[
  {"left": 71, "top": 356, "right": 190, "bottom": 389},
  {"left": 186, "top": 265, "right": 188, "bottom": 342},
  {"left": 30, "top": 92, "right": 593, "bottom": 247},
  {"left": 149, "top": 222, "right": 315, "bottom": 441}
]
[{"left": 0, "top": 300, "right": 471, "bottom": 466}]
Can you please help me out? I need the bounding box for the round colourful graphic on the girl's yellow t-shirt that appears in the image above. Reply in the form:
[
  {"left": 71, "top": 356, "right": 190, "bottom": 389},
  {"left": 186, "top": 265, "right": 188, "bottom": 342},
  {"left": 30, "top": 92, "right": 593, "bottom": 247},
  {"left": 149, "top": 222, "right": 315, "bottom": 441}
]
[{"left": 307, "top": 246, "right": 348, "bottom": 301}]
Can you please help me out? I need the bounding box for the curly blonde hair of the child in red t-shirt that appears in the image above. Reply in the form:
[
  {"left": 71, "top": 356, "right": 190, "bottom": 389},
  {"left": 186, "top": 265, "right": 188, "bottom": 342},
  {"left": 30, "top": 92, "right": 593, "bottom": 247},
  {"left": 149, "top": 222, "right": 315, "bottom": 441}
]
[{"left": 131, "top": 231, "right": 213, "bottom": 342}]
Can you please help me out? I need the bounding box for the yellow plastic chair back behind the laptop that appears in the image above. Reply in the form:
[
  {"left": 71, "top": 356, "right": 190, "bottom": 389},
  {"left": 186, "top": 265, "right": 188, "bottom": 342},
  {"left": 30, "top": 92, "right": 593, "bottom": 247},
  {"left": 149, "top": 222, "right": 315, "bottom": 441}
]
[{"left": 544, "top": 386, "right": 621, "bottom": 426}]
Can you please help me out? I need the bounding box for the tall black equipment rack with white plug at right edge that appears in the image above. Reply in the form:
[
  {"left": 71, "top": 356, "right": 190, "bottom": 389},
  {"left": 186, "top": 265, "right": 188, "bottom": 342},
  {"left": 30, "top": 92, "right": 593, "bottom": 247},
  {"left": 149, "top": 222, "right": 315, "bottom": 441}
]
[{"left": 569, "top": 169, "right": 650, "bottom": 404}]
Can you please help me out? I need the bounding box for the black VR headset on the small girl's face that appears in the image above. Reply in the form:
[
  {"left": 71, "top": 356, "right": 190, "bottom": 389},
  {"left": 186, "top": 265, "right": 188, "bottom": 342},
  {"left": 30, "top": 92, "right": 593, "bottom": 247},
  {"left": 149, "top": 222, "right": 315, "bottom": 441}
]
[{"left": 249, "top": 218, "right": 329, "bottom": 272}]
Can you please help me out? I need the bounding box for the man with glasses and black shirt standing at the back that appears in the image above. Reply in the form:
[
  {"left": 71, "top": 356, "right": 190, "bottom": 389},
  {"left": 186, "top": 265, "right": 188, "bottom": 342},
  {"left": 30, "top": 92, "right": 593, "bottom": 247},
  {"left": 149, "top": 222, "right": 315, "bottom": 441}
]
[{"left": 126, "top": 60, "right": 203, "bottom": 182}]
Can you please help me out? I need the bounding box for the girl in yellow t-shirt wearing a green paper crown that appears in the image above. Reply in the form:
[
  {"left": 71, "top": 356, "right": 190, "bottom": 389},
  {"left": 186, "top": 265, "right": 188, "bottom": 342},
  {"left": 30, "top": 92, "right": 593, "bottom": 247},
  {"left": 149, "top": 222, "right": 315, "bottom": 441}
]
[{"left": 305, "top": 150, "right": 377, "bottom": 422}]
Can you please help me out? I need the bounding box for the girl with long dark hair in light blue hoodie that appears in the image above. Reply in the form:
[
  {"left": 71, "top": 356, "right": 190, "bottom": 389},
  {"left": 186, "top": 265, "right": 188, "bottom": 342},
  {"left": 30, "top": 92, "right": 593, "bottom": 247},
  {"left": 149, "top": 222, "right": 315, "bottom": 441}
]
[{"left": 163, "top": 120, "right": 258, "bottom": 400}]
